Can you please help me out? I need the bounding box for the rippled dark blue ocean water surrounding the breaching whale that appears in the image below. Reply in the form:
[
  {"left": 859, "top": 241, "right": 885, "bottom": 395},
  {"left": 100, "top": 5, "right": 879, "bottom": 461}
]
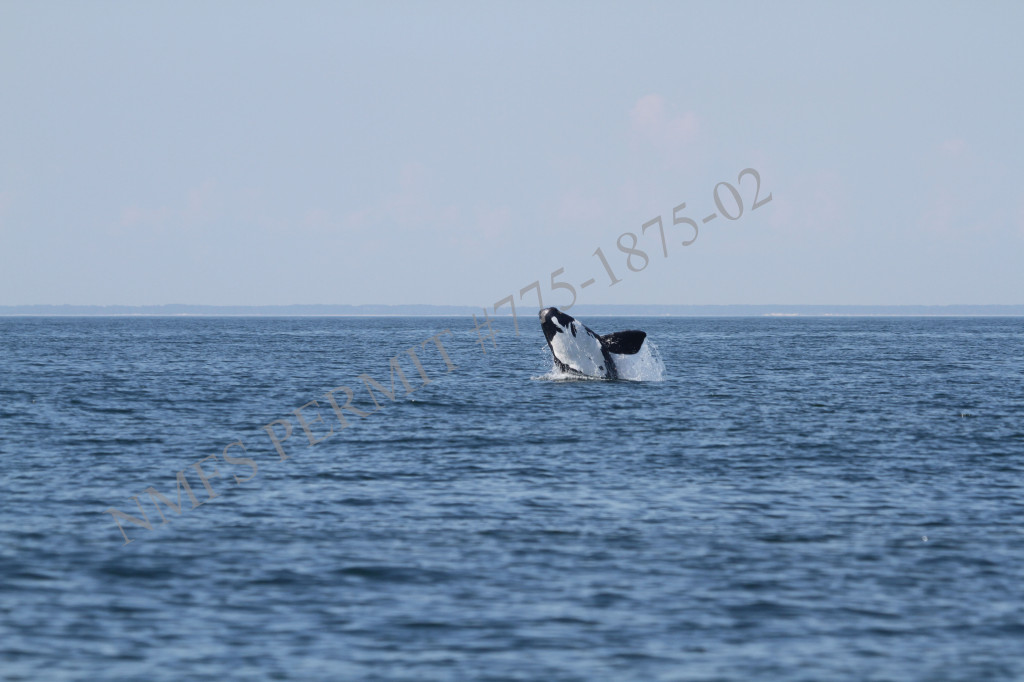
[{"left": 0, "top": 316, "right": 1024, "bottom": 681}]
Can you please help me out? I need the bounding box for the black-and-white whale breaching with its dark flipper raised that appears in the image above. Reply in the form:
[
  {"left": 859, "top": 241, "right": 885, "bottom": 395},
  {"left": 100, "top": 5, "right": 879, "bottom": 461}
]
[{"left": 540, "top": 308, "right": 647, "bottom": 379}]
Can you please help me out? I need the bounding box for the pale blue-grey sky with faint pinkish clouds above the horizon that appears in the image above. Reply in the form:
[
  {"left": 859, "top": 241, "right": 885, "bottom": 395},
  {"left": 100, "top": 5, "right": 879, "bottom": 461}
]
[{"left": 0, "top": 0, "right": 1024, "bottom": 309}]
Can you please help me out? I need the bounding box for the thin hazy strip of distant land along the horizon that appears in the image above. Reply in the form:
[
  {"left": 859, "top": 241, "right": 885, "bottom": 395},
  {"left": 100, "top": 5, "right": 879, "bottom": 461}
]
[{"left": 0, "top": 303, "right": 1024, "bottom": 317}]
